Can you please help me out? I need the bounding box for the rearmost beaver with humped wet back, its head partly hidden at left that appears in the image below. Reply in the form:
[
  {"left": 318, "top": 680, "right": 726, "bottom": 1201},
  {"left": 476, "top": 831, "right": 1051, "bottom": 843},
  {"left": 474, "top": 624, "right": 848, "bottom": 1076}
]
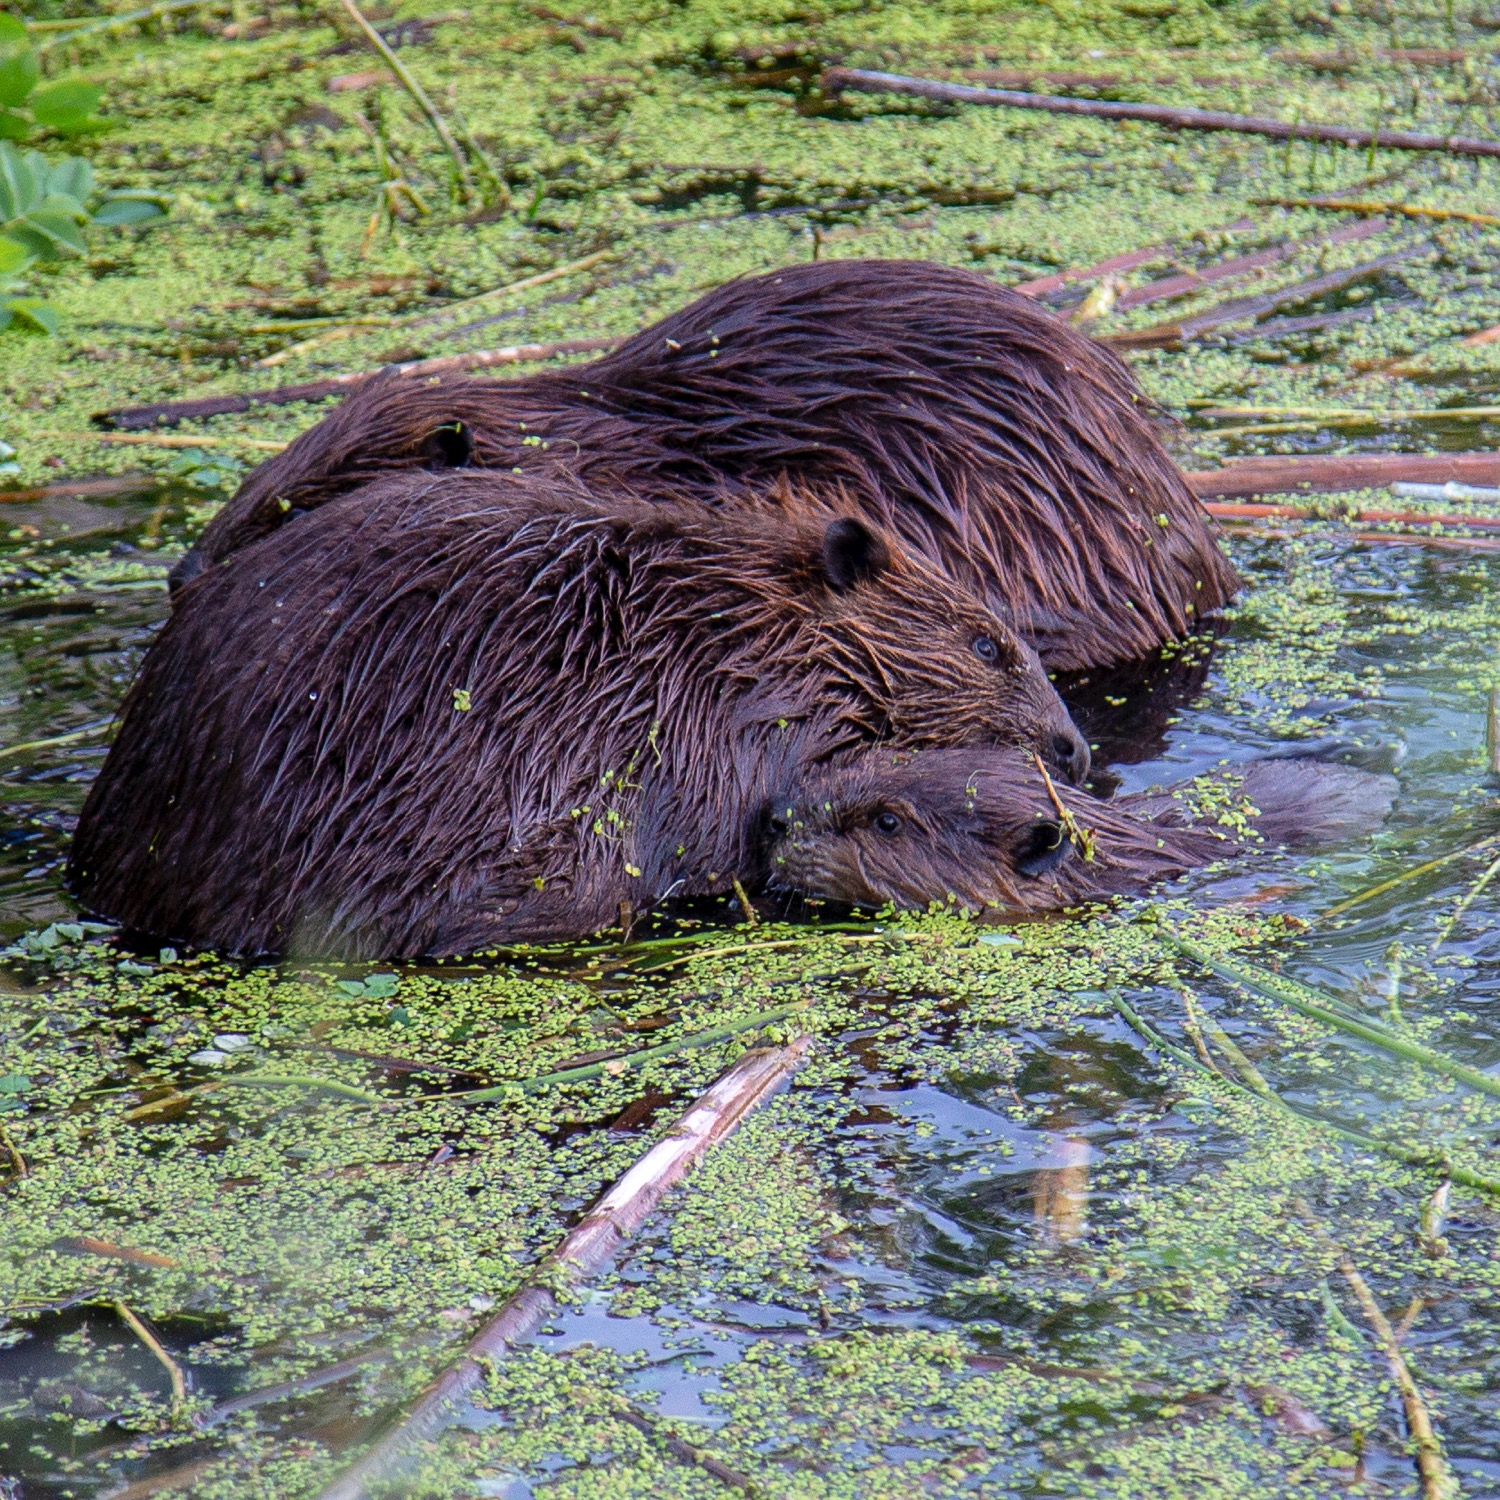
[{"left": 174, "top": 261, "right": 1239, "bottom": 671}]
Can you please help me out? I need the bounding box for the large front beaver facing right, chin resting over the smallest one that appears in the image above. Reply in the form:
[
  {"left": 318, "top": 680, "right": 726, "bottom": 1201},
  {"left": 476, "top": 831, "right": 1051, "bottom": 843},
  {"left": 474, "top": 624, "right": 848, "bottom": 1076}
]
[{"left": 68, "top": 473, "right": 1088, "bottom": 957}]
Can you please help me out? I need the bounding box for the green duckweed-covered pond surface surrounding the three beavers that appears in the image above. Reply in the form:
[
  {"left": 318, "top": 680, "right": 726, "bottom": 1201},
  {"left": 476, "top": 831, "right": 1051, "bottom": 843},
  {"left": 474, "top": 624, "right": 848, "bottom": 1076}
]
[{"left": 0, "top": 0, "right": 1500, "bottom": 1500}]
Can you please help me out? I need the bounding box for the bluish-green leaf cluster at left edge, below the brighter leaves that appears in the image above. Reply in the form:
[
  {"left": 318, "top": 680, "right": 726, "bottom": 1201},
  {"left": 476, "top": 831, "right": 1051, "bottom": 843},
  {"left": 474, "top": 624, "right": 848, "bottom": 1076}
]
[{"left": 0, "top": 140, "right": 167, "bottom": 333}]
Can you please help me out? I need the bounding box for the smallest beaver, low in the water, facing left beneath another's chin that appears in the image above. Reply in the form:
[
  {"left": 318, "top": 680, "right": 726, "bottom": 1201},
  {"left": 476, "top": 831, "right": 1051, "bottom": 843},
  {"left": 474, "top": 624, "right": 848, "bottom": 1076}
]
[{"left": 767, "top": 749, "right": 1395, "bottom": 917}]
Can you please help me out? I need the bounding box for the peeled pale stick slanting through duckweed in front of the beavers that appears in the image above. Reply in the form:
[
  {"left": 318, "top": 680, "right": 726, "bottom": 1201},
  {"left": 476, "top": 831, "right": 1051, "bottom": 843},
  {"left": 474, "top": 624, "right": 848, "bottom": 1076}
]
[{"left": 318, "top": 1035, "right": 812, "bottom": 1500}]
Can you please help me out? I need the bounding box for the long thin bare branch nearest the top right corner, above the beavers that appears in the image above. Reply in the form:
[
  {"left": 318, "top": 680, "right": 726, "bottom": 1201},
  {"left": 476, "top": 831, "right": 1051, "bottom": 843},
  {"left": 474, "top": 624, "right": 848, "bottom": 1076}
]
[{"left": 822, "top": 68, "right": 1500, "bottom": 156}]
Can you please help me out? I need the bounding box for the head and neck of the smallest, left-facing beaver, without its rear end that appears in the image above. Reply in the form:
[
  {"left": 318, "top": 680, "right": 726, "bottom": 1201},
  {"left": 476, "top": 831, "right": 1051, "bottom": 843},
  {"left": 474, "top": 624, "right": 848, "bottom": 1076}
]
[{"left": 767, "top": 750, "right": 1238, "bottom": 915}]
